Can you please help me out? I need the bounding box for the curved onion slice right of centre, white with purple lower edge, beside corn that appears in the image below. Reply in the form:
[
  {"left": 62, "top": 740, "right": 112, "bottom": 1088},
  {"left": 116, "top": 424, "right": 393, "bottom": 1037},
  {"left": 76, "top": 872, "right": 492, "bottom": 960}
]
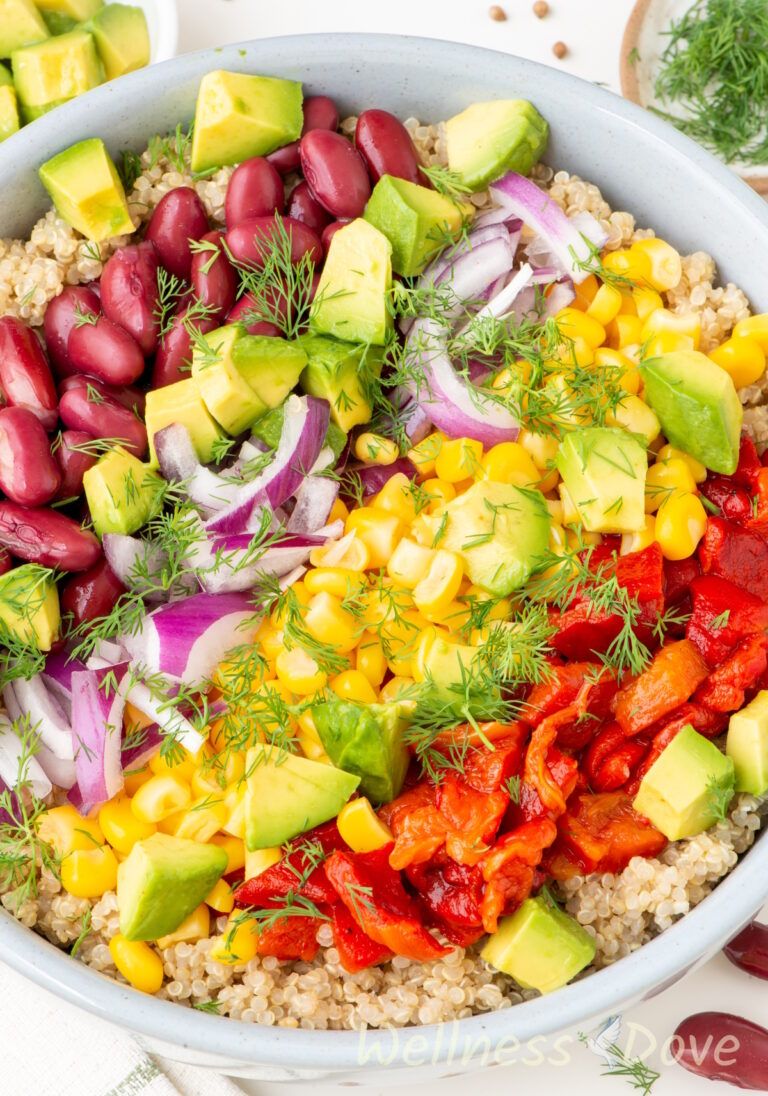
[{"left": 409, "top": 320, "right": 520, "bottom": 446}]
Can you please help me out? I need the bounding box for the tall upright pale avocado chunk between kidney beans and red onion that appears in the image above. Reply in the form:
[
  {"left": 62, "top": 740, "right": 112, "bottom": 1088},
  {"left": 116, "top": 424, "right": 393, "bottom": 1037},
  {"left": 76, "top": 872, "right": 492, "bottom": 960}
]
[{"left": 310, "top": 217, "right": 392, "bottom": 346}]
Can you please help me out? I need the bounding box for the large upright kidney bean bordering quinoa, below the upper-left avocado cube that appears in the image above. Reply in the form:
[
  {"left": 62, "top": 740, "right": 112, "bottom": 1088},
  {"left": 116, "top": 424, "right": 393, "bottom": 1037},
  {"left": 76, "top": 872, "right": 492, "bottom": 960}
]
[{"left": 101, "top": 240, "right": 160, "bottom": 357}]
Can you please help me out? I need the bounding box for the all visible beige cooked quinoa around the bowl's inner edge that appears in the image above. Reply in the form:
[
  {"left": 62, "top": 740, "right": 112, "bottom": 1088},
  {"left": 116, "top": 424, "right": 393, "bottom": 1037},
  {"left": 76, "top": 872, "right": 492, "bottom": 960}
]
[{"left": 0, "top": 116, "right": 768, "bottom": 1030}]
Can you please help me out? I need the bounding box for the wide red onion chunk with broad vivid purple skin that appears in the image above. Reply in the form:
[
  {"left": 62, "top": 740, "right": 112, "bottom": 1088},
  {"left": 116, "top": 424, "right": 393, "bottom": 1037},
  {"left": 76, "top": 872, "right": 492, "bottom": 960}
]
[{"left": 123, "top": 593, "right": 256, "bottom": 683}]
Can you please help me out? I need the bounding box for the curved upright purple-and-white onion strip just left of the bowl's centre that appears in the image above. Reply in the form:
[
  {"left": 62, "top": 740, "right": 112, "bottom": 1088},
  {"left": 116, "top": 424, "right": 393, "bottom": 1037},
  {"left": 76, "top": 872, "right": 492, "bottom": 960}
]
[{"left": 206, "top": 396, "right": 331, "bottom": 536}]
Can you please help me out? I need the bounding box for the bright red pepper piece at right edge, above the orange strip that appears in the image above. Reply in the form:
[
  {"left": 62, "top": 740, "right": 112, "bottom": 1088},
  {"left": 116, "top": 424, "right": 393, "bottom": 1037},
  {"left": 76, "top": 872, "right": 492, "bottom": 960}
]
[{"left": 686, "top": 574, "right": 768, "bottom": 669}]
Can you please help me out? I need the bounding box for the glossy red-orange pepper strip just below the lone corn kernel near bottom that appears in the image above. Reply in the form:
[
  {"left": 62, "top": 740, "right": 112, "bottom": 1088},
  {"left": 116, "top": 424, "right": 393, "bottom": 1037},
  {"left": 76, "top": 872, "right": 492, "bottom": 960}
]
[{"left": 325, "top": 845, "right": 450, "bottom": 962}]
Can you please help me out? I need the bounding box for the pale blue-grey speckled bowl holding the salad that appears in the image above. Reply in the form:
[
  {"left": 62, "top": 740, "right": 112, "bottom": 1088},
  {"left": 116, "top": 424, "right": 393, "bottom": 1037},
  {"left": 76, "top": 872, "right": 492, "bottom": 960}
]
[{"left": 0, "top": 35, "right": 768, "bottom": 1084}]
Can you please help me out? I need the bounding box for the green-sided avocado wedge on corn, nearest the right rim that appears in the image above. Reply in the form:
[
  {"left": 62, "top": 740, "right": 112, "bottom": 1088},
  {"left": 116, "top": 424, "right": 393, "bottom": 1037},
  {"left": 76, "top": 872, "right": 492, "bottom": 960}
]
[{"left": 640, "top": 350, "right": 743, "bottom": 476}]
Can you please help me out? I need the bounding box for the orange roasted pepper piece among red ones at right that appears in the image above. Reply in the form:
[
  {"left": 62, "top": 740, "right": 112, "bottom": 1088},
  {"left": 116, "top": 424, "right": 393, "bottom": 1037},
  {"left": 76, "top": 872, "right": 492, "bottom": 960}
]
[{"left": 616, "top": 639, "right": 708, "bottom": 734}]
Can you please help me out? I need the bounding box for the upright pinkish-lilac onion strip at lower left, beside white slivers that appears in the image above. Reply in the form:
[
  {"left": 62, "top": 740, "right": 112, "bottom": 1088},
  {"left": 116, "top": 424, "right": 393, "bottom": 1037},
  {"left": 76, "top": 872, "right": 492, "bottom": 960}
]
[{"left": 70, "top": 663, "right": 127, "bottom": 814}]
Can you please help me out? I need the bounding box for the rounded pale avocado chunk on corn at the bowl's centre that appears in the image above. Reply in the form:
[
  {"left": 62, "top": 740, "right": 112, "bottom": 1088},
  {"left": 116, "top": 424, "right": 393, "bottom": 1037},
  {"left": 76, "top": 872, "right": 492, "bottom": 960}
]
[{"left": 438, "top": 480, "right": 551, "bottom": 597}]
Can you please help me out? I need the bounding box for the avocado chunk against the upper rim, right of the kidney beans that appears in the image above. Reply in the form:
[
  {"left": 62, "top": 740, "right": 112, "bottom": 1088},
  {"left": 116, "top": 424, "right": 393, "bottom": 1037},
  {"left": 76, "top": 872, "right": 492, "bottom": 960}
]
[{"left": 446, "top": 99, "right": 549, "bottom": 191}]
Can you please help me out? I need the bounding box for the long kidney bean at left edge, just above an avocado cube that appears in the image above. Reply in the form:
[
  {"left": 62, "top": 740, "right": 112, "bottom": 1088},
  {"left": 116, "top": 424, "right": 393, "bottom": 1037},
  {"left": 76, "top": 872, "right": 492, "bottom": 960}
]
[{"left": 0, "top": 501, "right": 101, "bottom": 571}]
